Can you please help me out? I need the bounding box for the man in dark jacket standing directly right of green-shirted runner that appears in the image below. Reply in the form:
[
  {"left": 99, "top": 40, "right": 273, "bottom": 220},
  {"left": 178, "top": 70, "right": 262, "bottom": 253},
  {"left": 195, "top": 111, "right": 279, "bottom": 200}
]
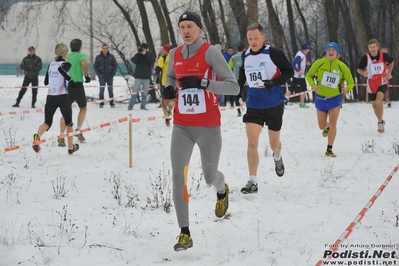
[{"left": 94, "top": 43, "right": 118, "bottom": 108}]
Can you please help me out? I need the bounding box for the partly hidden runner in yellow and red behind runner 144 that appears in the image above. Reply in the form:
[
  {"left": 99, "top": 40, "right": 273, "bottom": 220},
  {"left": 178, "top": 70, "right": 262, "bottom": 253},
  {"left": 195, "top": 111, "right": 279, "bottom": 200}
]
[{"left": 154, "top": 44, "right": 173, "bottom": 126}]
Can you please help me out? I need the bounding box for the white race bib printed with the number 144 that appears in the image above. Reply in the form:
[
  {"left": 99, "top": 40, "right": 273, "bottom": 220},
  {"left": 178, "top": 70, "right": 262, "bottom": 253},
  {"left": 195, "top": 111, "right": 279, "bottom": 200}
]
[{"left": 178, "top": 88, "right": 206, "bottom": 115}]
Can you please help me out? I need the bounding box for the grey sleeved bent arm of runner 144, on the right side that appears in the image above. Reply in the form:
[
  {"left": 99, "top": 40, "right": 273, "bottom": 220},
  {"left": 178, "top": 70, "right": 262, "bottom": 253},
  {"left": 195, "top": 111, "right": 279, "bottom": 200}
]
[{"left": 205, "top": 46, "right": 240, "bottom": 95}]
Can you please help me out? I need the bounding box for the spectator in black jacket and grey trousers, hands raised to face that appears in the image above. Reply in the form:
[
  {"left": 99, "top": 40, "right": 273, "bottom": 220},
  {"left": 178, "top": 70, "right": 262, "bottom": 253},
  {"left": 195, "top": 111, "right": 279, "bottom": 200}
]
[{"left": 127, "top": 43, "right": 155, "bottom": 110}]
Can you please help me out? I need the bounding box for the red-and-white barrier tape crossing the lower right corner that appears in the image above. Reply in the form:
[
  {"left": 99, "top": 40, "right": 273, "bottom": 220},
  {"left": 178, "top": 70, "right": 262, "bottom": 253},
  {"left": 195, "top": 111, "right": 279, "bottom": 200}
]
[{"left": 316, "top": 163, "right": 399, "bottom": 266}]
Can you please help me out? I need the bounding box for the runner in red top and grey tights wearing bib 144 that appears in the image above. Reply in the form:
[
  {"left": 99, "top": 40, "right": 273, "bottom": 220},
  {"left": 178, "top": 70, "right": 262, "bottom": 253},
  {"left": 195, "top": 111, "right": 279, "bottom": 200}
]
[{"left": 164, "top": 11, "right": 240, "bottom": 251}]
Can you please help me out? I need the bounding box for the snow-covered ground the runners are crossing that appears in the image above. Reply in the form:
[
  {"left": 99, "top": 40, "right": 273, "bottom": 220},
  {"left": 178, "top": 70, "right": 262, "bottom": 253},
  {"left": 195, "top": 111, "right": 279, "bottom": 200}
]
[{"left": 0, "top": 76, "right": 399, "bottom": 266}]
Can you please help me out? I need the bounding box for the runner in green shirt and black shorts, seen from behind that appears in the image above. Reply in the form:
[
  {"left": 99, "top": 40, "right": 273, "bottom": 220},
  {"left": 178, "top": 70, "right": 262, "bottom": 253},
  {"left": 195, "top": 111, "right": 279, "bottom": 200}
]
[{"left": 58, "top": 39, "right": 91, "bottom": 147}]
